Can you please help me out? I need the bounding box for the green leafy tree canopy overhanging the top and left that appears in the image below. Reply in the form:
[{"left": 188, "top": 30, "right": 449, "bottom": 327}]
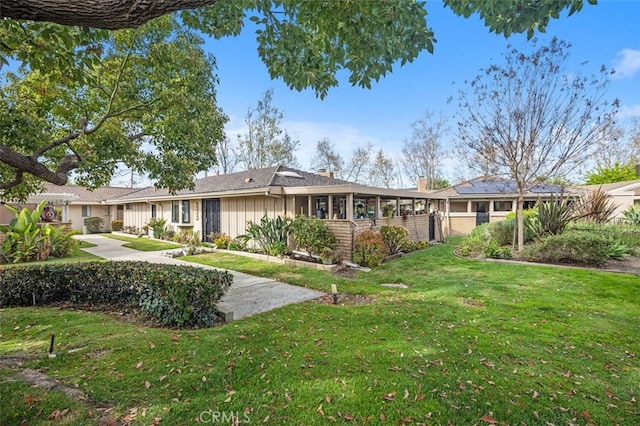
[{"left": 0, "top": 0, "right": 594, "bottom": 198}]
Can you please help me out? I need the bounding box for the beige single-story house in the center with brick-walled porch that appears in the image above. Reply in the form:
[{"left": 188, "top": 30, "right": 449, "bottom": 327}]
[{"left": 107, "top": 166, "right": 442, "bottom": 260}]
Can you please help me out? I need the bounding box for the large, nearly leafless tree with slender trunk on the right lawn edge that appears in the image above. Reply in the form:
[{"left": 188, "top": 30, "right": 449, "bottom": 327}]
[{"left": 458, "top": 39, "right": 618, "bottom": 250}]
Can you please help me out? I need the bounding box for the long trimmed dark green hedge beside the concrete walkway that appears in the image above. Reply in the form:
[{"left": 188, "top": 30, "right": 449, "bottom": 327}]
[{"left": 0, "top": 262, "right": 233, "bottom": 328}]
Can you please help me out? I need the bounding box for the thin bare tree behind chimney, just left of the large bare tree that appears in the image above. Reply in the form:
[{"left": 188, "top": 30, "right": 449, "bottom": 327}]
[{"left": 402, "top": 111, "right": 449, "bottom": 189}]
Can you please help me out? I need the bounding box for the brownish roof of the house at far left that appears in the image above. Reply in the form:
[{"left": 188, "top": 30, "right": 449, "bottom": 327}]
[{"left": 28, "top": 183, "right": 139, "bottom": 204}]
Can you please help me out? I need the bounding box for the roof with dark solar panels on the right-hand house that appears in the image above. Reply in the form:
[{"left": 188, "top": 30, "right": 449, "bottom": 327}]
[{"left": 438, "top": 177, "right": 567, "bottom": 198}]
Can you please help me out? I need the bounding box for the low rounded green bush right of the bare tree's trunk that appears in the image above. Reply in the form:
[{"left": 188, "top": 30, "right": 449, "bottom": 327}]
[{"left": 521, "top": 231, "right": 629, "bottom": 266}]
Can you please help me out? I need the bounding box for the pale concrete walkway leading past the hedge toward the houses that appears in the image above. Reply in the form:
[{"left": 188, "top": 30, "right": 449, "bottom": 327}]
[{"left": 76, "top": 234, "right": 324, "bottom": 322}]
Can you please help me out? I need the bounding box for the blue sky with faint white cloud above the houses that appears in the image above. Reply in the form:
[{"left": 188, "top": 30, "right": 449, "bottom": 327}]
[{"left": 207, "top": 0, "right": 640, "bottom": 186}]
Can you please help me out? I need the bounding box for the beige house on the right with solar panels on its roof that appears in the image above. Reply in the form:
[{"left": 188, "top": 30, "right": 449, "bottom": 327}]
[{"left": 418, "top": 178, "right": 576, "bottom": 236}]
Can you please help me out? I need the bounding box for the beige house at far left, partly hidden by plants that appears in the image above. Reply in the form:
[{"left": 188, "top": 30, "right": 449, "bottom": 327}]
[{"left": 0, "top": 184, "right": 139, "bottom": 231}]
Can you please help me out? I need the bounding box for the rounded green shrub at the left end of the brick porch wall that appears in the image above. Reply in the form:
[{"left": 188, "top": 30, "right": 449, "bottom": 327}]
[{"left": 291, "top": 216, "right": 338, "bottom": 261}]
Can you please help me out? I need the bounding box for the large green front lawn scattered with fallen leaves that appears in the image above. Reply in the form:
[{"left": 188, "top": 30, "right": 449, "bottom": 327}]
[{"left": 0, "top": 244, "right": 640, "bottom": 425}]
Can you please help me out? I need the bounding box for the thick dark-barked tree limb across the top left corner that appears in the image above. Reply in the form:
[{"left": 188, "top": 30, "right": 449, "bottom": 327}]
[{"left": 0, "top": 0, "right": 217, "bottom": 30}]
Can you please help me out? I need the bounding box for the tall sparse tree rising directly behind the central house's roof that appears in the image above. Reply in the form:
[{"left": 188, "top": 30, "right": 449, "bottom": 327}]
[{"left": 237, "top": 89, "right": 300, "bottom": 170}]
